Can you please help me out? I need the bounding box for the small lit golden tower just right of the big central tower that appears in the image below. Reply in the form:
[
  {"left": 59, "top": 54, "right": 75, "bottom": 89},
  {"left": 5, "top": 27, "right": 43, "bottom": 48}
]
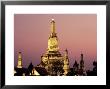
[{"left": 63, "top": 49, "right": 70, "bottom": 75}]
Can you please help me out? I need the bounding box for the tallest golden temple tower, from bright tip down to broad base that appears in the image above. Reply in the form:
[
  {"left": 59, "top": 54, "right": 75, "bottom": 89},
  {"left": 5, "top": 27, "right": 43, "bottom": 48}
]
[{"left": 39, "top": 19, "right": 69, "bottom": 76}]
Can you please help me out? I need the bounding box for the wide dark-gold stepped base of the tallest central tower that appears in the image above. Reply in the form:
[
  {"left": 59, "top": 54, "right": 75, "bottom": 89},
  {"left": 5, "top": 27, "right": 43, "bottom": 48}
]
[{"left": 41, "top": 51, "right": 64, "bottom": 75}]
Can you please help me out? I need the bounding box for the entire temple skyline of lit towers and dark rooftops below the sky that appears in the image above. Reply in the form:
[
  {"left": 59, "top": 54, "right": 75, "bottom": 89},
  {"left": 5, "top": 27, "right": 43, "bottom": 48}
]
[{"left": 14, "top": 19, "right": 90, "bottom": 76}]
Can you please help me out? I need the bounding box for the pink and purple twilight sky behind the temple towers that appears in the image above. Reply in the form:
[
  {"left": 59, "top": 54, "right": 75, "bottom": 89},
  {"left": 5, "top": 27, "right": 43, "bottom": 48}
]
[{"left": 14, "top": 14, "right": 97, "bottom": 69}]
